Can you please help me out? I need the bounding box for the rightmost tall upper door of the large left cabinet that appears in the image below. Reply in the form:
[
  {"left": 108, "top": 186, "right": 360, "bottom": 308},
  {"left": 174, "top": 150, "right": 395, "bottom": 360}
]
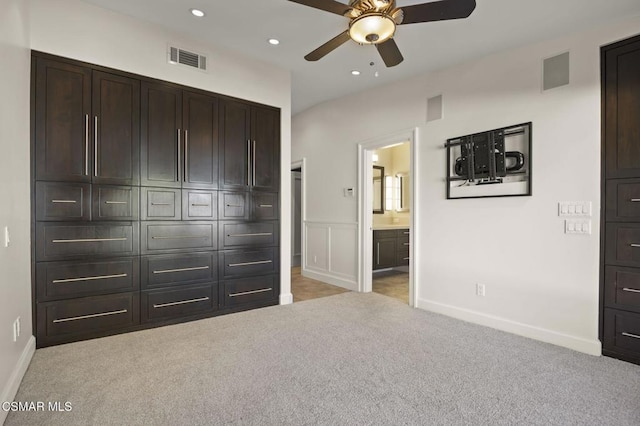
[{"left": 251, "top": 107, "right": 280, "bottom": 191}]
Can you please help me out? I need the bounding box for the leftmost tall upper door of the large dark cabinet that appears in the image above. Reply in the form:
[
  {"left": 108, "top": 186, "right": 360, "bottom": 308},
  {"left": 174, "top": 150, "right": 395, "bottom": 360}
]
[{"left": 34, "top": 58, "right": 91, "bottom": 182}]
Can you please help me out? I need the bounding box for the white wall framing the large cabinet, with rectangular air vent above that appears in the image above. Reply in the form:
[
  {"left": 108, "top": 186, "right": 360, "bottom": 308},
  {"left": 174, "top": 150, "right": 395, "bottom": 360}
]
[{"left": 31, "top": 0, "right": 292, "bottom": 303}]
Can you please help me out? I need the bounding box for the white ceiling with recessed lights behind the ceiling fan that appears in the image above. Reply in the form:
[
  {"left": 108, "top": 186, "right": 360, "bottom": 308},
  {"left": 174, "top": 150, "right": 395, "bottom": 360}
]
[{"left": 84, "top": 0, "right": 640, "bottom": 114}]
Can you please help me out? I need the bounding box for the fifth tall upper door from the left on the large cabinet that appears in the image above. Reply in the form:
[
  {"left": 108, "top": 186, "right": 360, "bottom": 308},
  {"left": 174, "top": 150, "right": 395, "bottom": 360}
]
[{"left": 220, "top": 101, "right": 251, "bottom": 190}]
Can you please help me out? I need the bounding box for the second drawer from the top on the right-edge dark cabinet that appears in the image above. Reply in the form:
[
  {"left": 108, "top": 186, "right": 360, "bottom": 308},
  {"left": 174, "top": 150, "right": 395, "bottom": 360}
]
[{"left": 605, "top": 223, "right": 640, "bottom": 266}]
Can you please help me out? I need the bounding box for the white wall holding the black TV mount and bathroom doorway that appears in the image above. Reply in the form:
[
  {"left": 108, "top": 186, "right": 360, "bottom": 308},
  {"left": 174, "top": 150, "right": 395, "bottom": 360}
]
[{"left": 292, "top": 17, "right": 640, "bottom": 354}]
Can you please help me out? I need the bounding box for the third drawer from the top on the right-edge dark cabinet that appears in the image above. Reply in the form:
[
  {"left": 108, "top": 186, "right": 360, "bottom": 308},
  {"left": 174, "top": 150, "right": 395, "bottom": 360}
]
[{"left": 604, "top": 266, "right": 640, "bottom": 313}]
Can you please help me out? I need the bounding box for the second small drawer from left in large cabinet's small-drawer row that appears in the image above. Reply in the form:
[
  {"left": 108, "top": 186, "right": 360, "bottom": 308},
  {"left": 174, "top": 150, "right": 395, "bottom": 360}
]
[{"left": 92, "top": 186, "right": 140, "bottom": 220}]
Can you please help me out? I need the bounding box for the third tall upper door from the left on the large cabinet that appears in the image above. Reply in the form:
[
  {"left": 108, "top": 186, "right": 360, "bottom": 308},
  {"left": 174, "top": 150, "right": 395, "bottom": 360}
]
[{"left": 140, "top": 83, "right": 183, "bottom": 188}]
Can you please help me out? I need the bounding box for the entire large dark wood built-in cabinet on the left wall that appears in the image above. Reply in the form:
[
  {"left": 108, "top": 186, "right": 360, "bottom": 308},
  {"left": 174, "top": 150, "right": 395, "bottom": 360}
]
[{"left": 32, "top": 52, "right": 280, "bottom": 347}]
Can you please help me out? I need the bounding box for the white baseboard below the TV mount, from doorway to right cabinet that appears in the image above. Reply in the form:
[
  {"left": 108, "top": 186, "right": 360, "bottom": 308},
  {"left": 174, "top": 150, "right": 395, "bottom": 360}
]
[{"left": 417, "top": 299, "right": 602, "bottom": 356}]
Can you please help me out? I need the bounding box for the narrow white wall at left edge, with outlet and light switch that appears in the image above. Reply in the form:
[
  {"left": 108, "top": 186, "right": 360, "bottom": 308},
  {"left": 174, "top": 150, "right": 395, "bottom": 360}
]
[{"left": 0, "top": 0, "right": 35, "bottom": 424}]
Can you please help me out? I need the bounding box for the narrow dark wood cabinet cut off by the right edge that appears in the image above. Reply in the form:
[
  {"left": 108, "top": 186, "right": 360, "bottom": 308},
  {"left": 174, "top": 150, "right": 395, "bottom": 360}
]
[{"left": 601, "top": 36, "right": 640, "bottom": 364}]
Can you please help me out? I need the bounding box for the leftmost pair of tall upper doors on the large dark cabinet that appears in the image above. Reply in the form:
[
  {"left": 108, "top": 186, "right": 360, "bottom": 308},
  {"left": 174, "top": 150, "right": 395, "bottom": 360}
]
[{"left": 34, "top": 58, "right": 140, "bottom": 185}]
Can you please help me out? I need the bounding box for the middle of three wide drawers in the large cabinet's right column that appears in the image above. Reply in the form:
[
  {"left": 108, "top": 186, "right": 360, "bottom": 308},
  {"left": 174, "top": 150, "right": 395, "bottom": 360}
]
[{"left": 219, "top": 247, "right": 279, "bottom": 279}]
